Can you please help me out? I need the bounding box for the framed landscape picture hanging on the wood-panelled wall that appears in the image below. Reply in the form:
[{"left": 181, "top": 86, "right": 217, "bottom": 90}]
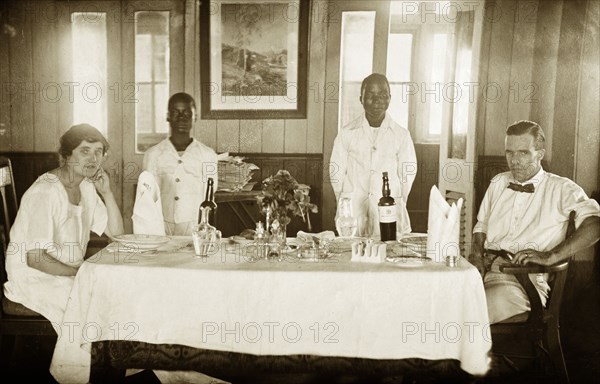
[{"left": 200, "top": 0, "right": 309, "bottom": 119}]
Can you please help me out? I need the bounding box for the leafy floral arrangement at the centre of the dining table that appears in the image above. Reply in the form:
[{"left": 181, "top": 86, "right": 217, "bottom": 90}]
[{"left": 257, "top": 170, "right": 317, "bottom": 231}]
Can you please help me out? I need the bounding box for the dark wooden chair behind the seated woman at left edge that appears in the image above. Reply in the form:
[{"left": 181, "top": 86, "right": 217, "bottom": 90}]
[{"left": 0, "top": 156, "right": 56, "bottom": 368}]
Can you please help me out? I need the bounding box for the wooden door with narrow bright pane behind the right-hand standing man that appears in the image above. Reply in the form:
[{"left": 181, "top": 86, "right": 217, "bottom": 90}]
[{"left": 322, "top": 1, "right": 390, "bottom": 228}]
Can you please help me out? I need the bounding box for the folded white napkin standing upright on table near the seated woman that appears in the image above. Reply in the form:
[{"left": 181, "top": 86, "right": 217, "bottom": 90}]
[{"left": 131, "top": 171, "right": 165, "bottom": 236}]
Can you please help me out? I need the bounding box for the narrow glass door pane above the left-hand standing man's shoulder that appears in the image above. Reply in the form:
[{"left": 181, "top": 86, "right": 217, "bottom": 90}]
[{"left": 135, "top": 11, "right": 169, "bottom": 152}]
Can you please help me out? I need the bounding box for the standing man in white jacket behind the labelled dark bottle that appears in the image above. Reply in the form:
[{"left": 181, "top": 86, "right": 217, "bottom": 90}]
[{"left": 330, "top": 73, "right": 417, "bottom": 237}]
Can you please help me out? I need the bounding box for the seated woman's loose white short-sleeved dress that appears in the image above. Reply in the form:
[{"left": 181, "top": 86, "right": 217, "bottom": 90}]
[{"left": 4, "top": 173, "right": 108, "bottom": 326}]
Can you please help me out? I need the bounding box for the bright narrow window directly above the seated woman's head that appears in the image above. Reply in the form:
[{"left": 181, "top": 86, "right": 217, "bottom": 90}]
[{"left": 71, "top": 12, "right": 108, "bottom": 136}]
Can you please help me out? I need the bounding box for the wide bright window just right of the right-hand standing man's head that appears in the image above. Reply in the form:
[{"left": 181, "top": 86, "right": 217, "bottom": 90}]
[{"left": 387, "top": 1, "right": 462, "bottom": 143}]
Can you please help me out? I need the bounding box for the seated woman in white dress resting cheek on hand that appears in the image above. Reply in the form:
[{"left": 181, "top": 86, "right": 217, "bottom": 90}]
[{"left": 4, "top": 124, "right": 123, "bottom": 327}]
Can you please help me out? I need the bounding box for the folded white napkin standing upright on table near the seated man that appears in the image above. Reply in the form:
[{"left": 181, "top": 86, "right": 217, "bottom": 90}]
[{"left": 427, "top": 185, "right": 463, "bottom": 262}]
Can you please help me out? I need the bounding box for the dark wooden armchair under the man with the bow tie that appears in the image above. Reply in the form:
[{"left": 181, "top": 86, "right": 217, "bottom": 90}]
[{"left": 491, "top": 211, "right": 575, "bottom": 383}]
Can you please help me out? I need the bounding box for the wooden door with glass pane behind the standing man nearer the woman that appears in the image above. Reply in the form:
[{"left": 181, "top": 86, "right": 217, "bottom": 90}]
[{"left": 121, "top": 0, "right": 185, "bottom": 233}]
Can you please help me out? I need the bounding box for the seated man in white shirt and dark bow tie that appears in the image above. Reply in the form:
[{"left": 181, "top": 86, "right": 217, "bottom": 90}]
[{"left": 469, "top": 120, "right": 600, "bottom": 323}]
